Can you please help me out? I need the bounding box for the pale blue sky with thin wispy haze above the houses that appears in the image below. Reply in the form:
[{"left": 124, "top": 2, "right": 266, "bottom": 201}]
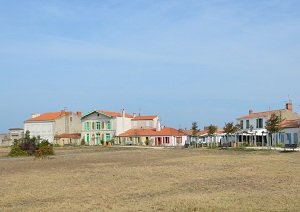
[{"left": 0, "top": 0, "right": 300, "bottom": 132}]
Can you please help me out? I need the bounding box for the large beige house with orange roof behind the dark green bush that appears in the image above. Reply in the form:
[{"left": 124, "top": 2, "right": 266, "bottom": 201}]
[{"left": 24, "top": 110, "right": 81, "bottom": 143}]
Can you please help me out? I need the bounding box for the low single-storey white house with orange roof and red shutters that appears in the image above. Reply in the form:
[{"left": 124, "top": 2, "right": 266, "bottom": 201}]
[{"left": 117, "top": 124, "right": 187, "bottom": 147}]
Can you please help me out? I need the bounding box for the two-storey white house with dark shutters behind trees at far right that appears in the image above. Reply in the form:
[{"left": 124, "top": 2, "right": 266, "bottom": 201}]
[{"left": 237, "top": 102, "right": 300, "bottom": 146}]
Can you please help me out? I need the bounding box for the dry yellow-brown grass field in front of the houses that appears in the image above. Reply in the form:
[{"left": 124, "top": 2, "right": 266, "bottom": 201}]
[{"left": 0, "top": 147, "right": 300, "bottom": 211}]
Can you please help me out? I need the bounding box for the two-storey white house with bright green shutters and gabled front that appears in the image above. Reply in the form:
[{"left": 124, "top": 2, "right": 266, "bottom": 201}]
[{"left": 81, "top": 109, "right": 133, "bottom": 145}]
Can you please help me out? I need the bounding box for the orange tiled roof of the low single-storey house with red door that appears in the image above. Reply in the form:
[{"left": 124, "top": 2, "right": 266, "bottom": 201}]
[{"left": 119, "top": 127, "right": 185, "bottom": 137}]
